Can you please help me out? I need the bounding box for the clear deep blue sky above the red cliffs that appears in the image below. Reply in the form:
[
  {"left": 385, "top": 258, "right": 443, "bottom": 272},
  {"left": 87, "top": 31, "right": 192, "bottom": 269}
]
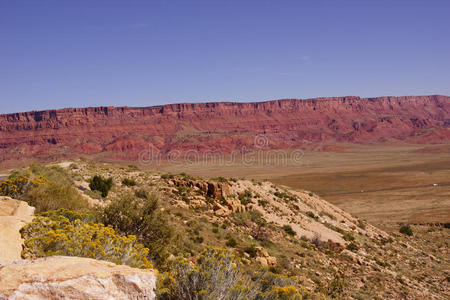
[{"left": 0, "top": 0, "right": 450, "bottom": 113}]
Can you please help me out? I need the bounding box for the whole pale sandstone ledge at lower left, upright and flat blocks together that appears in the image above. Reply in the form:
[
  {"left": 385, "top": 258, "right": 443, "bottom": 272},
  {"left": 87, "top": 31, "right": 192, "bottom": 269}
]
[{"left": 0, "top": 197, "right": 156, "bottom": 300}]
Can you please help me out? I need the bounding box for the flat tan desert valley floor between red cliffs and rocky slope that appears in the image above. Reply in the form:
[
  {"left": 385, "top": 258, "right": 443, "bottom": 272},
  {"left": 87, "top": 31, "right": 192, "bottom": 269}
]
[{"left": 155, "top": 144, "right": 450, "bottom": 227}]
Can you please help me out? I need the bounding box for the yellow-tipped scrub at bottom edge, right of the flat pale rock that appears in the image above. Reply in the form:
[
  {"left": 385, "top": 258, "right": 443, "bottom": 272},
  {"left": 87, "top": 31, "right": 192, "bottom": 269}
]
[{"left": 157, "top": 247, "right": 311, "bottom": 300}]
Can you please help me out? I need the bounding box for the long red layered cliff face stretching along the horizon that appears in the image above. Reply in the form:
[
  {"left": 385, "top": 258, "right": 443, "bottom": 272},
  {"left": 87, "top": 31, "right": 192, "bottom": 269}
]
[{"left": 0, "top": 96, "right": 450, "bottom": 160}]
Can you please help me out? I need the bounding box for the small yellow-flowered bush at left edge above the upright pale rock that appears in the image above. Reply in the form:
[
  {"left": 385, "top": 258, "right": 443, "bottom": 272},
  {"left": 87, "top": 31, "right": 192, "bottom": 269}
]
[{"left": 0, "top": 172, "right": 47, "bottom": 199}]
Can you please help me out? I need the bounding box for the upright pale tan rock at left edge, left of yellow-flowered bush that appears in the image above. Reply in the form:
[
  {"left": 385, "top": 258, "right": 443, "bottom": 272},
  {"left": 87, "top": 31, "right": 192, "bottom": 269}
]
[{"left": 0, "top": 197, "right": 34, "bottom": 265}]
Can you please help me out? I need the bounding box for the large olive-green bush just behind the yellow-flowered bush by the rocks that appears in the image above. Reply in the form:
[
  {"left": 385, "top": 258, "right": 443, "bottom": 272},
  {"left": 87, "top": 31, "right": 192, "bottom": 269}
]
[{"left": 100, "top": 193, "right": 175, "bottom": 264}]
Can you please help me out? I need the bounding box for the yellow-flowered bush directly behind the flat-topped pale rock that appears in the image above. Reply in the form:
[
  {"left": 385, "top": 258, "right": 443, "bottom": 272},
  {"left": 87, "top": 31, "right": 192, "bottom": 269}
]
[{"left": 21, "top": 210, "right": 152, "bottom": 268}]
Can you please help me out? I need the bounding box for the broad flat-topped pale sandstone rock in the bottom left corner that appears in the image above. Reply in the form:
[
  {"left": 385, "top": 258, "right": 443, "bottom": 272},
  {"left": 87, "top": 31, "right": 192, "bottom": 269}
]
[{"left": 0, "top": 256, "right": 156, "bottom": 300}]
